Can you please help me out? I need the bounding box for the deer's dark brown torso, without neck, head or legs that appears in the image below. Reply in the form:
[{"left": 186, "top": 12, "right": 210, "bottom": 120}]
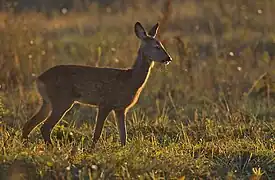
[{"left": 38, "top": 65, "right": 142, "bottom": 108}]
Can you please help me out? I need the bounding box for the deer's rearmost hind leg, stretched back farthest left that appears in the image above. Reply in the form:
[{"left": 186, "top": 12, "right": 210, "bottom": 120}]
[{"left": 22, "top": 81, "right": 52, "bottom": 139}]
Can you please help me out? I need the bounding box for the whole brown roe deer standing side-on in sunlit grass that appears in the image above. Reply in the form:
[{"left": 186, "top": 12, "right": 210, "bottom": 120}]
[{"left": 22, "top": 22, "right": 172, "bottom": 146}]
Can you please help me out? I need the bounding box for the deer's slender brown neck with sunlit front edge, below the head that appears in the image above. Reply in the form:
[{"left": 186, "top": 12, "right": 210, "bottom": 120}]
[{"left": 131, "top": 50, "right": 154, "bottom": 89}]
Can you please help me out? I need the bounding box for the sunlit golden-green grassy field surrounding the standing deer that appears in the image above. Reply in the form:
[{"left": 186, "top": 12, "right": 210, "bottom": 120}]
[{"left": 0, "top": 0, "right": 275, "bottom": 180}]
